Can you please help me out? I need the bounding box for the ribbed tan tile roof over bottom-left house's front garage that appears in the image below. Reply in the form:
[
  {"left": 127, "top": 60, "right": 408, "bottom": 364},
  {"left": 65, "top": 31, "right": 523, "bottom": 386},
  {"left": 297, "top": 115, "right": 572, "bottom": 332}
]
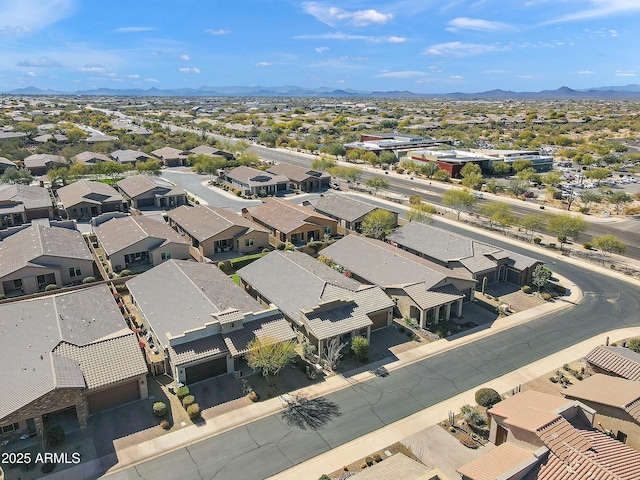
[{"left": 54, "top": 329, "right": 147, "bottom": 389}]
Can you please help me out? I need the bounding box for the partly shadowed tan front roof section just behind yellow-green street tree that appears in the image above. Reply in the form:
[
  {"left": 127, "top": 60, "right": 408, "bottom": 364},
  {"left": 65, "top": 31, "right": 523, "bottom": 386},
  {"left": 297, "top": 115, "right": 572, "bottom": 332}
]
[{"left": 222, "top": 312, "right": 296, "bottom": 357}]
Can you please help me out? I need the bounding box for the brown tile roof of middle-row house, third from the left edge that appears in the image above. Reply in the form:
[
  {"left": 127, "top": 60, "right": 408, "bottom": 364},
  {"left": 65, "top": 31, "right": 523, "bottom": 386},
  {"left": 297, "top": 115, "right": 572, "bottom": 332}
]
[{"left": 167, "top": 205, "right": 267, "bottom": 242}]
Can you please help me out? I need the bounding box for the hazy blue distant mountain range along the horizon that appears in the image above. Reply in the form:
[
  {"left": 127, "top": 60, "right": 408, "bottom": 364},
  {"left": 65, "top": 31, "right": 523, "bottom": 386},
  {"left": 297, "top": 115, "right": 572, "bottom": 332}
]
[{"left": 4, "top": 84, "right": 640, "bottom": 100}]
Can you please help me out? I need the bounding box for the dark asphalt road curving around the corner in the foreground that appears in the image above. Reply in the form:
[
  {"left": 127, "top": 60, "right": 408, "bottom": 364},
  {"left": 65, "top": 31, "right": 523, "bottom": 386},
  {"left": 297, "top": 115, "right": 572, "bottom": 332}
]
[{"left": 109, "top": 222, "right": 640, "bottom": 480}]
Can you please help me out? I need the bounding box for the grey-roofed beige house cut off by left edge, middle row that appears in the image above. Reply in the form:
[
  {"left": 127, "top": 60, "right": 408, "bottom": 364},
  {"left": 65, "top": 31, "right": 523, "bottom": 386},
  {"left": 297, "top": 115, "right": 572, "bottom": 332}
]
[{"left": 0, "top": 223, "right": 94, "bottom": 296}]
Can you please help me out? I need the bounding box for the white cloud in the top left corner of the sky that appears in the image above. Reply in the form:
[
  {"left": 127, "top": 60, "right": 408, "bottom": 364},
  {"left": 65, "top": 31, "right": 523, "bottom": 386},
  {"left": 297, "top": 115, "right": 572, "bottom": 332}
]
[{"left": 0, "top": 0, "right": 75, "bottom": 35}]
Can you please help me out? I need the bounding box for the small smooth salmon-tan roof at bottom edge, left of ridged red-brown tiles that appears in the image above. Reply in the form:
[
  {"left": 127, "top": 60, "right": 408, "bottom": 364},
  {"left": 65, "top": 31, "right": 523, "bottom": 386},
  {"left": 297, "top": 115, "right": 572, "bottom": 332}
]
[{"left": 456, "top": 443, "right": 532, "bottom": 480}]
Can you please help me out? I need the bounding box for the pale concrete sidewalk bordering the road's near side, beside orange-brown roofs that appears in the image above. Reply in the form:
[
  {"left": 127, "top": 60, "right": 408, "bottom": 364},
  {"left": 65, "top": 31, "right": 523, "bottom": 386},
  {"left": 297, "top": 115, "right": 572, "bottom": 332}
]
[{"left": 269, "top": 327, "right": 640, "bottom": 480}]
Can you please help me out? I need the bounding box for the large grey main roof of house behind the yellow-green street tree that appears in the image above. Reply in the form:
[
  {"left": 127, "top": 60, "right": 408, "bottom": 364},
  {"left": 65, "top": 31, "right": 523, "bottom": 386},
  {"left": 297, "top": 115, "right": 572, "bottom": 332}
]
[{"left": 127, "top": 260, "right": 264, "bottom": 348}]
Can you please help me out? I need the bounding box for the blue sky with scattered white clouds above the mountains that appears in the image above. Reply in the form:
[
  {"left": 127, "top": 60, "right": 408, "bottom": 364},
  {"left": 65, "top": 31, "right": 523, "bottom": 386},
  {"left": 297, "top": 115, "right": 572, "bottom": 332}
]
[{"left": 0, "top": 0, "right": 640, "bottom": 93}]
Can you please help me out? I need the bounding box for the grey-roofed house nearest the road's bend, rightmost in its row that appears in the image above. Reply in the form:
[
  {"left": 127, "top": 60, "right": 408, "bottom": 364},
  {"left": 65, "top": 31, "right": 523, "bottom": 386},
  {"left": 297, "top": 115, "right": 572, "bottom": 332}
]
[{"left": 387, "top": 222, "right": 543, "bottom": 289}]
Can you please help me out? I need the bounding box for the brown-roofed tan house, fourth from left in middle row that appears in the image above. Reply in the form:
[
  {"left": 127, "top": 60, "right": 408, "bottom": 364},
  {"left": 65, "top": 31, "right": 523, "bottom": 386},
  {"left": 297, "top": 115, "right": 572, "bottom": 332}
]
[{"left": 242, "top": 197, "right": 338, "bottom": 247}]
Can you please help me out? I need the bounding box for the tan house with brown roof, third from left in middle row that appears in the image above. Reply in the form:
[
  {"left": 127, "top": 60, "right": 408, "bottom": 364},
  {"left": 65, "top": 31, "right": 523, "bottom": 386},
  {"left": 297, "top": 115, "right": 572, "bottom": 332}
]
[{"left": 167, "top": 205, "right": 269, "bottom": 257}]
